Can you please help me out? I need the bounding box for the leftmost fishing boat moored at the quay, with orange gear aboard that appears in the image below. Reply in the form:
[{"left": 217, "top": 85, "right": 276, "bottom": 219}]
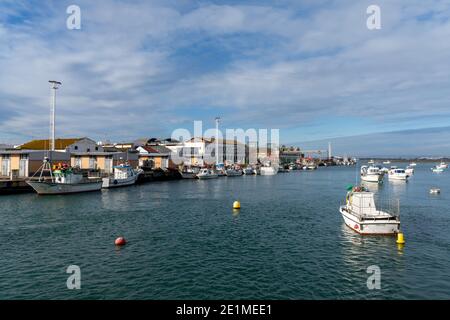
[{"left": 26, "top": 157, "right": 103, "bottom": 195}]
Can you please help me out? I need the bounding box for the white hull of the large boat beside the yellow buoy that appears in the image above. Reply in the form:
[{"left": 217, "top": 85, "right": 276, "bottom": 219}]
[{"left": 339, "top": 206, "right": 400, "bottom": 235}]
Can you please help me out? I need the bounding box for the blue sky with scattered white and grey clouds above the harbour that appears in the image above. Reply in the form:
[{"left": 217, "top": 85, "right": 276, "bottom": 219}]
[{"left": 0, "top": 0, "right": 450, "bottom": 155}]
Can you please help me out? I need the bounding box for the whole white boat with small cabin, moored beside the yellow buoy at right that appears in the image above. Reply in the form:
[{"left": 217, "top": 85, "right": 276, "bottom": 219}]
[{"left": 339, "top": 186, "right": 400, "bottom": 235}]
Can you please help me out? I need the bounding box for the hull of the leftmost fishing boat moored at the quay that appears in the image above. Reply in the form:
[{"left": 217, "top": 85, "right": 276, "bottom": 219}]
[{"left": 27, "top": 181, "right": 103, "bottom": 195}]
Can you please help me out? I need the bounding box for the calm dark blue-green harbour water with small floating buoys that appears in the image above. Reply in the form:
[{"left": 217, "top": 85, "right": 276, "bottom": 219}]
[{"left": 0, "top": 164, "right": 450, "bottom": 299}]
